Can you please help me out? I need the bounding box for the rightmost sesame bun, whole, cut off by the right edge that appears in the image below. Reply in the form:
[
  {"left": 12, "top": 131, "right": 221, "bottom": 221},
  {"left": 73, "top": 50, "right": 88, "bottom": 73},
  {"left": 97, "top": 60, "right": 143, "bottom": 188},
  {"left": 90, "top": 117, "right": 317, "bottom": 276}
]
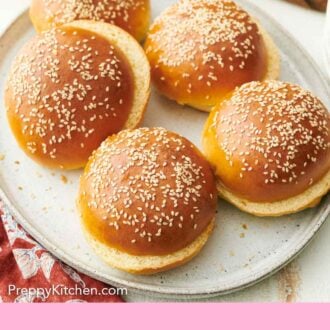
[{"left": 203, "top": 81, "right": 330, "bottom": 215}]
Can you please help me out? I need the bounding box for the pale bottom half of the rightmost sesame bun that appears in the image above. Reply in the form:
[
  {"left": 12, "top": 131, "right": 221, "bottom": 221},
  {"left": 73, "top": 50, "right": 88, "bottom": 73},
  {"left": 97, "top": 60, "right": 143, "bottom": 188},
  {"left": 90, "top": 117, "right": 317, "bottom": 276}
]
[{"left": 217, "top": 171, "right": 330, "bottom": 217}]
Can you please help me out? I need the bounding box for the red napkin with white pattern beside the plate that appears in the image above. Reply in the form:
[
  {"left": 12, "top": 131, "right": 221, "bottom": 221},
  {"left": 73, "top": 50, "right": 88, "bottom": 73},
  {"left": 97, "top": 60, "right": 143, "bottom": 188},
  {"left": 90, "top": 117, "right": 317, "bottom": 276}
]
[{"left": 0, "top": 200, "right": 123, "bottom": 303}]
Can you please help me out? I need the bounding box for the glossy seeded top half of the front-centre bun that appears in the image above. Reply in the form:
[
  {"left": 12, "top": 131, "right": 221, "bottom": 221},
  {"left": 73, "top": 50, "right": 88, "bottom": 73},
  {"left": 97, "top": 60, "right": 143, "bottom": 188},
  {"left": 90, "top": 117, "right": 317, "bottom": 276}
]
[{"left": 80, "top": 128, "right": 217, "bottom": 255}]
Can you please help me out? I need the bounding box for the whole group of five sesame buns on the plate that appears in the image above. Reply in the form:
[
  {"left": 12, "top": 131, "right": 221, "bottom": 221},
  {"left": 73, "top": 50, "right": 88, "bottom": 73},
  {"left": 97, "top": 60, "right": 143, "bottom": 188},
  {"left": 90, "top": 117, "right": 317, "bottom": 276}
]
[{"left": 5, "top": 0, "right": 330, "bottom": 274}]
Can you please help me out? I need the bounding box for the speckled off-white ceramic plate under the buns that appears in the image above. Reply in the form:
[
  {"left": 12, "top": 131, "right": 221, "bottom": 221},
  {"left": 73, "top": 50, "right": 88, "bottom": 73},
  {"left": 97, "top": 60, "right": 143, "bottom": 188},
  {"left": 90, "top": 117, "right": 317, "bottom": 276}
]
[{"left": 0, "top": 0, "right": 330, "bottom": 298}]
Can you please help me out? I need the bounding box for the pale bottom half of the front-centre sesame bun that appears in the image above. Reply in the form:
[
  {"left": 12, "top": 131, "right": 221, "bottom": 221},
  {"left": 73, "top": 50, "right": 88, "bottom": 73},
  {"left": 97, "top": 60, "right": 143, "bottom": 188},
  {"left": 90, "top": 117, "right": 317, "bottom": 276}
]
[{"left": 84, "top": 219, "right": 215, "bottom": 275}]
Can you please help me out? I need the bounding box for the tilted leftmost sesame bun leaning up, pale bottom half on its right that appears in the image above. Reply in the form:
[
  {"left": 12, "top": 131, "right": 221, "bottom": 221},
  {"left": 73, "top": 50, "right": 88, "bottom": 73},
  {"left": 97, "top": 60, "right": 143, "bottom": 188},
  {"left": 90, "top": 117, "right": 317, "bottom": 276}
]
[{"left": 5, "top": 21, "right": 150, "bottom": 169}]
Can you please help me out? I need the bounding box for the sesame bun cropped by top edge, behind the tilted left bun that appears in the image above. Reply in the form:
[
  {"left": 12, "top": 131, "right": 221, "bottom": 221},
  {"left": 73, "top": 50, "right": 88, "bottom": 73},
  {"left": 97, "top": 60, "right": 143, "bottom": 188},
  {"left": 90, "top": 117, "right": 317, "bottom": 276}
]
[{"left": 30, "top": 0, "right": 150, "bottom": 41}]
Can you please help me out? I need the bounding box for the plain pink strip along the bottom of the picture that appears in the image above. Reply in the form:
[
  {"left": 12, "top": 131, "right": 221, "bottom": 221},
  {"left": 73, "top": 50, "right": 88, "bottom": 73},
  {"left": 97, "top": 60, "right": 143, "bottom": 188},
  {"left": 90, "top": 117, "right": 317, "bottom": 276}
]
[{"left": 0, "top": 304, "right": 330, "bottom": 330}]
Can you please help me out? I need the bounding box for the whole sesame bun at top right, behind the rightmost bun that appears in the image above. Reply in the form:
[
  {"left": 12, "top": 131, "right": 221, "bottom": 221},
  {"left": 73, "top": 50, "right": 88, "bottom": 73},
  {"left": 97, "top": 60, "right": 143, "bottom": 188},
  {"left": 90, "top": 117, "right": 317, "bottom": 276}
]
[{"left": 144, "top": 0, "right": 279, "bottom": 111}]
